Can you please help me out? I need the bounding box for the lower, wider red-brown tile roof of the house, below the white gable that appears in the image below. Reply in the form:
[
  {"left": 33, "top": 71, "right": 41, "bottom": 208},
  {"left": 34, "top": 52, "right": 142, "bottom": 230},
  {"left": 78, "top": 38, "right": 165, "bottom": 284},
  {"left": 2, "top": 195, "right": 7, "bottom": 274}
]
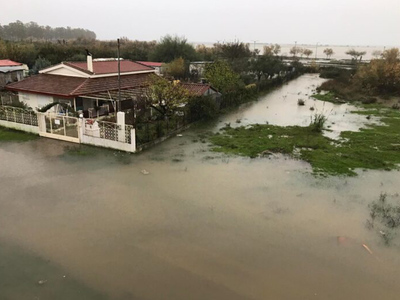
[{"left": 6, "top": 73, "right": 152, "bottom": 97}]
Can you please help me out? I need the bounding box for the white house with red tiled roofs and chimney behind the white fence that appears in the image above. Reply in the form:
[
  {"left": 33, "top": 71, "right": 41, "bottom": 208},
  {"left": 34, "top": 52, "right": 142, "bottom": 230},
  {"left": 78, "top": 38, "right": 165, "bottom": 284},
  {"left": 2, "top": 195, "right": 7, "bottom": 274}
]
[{"left": 6, "top": 55, "right": 155, "bottom": 116}]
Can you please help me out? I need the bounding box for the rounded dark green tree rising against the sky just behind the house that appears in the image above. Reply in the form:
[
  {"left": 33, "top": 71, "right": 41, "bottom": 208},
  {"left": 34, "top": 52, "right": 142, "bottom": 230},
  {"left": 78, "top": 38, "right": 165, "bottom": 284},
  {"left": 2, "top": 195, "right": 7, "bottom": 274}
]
[{"left": 150, "top": 35, "right": 197, "bottom": 63}]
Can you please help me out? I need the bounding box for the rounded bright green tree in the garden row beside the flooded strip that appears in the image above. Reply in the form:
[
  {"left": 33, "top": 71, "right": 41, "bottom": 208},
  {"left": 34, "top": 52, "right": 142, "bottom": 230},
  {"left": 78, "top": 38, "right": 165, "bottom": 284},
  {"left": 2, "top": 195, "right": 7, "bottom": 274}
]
[{"left": 204, "top": 60, "right": 240, "bottom": 93}]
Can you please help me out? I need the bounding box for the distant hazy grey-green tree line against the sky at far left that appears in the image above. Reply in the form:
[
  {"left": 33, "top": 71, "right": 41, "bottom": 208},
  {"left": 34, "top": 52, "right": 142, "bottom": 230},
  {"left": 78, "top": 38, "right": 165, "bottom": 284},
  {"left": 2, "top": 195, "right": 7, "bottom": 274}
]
[{"left": 0, "top": 21, "right": 96, "bottom": 43}]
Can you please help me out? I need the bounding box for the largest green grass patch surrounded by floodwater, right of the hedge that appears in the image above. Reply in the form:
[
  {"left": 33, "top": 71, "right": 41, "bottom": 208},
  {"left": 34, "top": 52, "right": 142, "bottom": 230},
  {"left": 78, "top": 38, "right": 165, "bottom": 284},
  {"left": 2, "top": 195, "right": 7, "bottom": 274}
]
[{"left": 210, "top": 109, "right": 400, "bottom": 176}]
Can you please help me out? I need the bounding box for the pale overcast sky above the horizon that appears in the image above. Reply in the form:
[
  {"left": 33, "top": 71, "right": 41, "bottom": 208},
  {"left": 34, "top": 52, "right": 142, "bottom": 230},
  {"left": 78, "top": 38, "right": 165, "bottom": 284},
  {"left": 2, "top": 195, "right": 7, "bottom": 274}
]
[{"left": 0, "top": 0, "right": 400, "bottom": 46}]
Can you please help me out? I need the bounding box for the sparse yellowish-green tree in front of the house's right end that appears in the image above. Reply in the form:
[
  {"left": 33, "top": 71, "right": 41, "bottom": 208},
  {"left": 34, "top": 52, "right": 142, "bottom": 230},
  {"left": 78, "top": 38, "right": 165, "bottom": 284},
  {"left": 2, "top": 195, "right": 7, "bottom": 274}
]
[{"left": 145, "top": 75, "right": 190, "bottom": 121}]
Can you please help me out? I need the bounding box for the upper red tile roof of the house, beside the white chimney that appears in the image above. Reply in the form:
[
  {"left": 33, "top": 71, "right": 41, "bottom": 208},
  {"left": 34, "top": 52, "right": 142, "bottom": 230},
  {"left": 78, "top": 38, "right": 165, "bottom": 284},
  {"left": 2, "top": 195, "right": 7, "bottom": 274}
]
[{"left": 63, "top": 60, "right": 153, "bottom": 75}]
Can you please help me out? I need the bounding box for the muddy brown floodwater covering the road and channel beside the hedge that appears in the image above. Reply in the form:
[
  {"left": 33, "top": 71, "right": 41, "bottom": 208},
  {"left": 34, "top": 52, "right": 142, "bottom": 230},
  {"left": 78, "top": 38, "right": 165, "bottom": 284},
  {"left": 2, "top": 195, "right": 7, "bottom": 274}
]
[{"left": 0, "top": 75, "right": 400, "bottom": 300}]
